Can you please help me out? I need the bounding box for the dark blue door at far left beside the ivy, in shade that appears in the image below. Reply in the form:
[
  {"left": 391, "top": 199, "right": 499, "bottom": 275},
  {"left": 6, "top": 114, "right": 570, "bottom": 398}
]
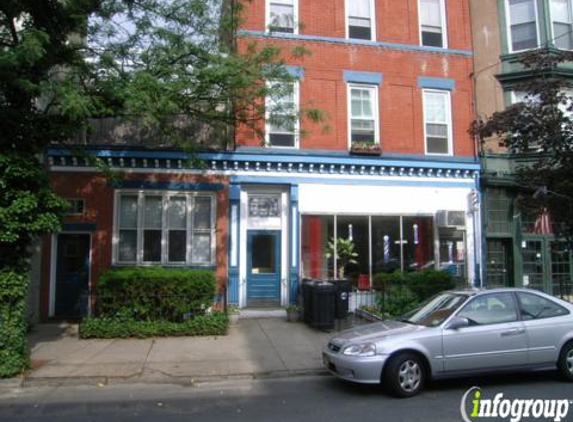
[{"left": 54, "top": 234, "right": 90, "bottom": 318}]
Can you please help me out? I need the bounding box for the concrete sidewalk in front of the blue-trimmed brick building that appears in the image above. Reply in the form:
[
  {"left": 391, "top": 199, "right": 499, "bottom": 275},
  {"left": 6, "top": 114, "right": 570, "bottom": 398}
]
[{"left": 23, "top": 318, "right": 335, "bottom": 385}]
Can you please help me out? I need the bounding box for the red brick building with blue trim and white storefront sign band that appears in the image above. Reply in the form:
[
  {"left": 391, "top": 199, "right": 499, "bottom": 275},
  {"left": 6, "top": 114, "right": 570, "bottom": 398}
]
[{"left": 38, "top": 0, "right": 481, "bottom": 317}]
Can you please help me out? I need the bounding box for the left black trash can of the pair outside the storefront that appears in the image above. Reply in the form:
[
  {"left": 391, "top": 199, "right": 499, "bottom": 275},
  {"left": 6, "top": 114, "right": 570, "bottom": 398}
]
[{"left": 302, "top": 280, "right": 336, "bottom": 330}]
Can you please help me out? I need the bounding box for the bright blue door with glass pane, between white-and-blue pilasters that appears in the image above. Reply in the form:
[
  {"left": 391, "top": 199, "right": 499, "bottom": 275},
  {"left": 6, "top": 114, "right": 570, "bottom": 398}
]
[{"left": 247, "top": 230, "right": 281, "bottom": 302}]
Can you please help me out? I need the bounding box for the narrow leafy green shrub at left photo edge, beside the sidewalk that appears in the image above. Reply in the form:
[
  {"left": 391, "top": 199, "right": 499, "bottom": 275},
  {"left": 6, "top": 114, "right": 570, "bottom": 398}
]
[{"left": 0, "top": 268, "right": 30, "bottom": 378}]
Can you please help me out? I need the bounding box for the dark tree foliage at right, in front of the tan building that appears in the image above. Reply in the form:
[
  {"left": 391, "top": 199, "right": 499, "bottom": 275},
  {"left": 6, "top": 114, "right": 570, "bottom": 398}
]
[{"left": 474, "top": 49, "right": 573, "bottom": 243}]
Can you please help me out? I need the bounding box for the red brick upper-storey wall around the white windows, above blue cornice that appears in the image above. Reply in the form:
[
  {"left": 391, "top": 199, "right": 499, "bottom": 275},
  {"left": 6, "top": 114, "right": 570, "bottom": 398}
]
[{"left": 237, "top": 0, "right": 476, "bottom": 156}]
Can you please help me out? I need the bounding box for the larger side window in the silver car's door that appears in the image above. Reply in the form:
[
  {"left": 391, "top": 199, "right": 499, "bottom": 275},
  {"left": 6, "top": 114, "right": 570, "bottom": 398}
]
[{"left": 458, "top": 293, "right": 517, "bottom": 325}]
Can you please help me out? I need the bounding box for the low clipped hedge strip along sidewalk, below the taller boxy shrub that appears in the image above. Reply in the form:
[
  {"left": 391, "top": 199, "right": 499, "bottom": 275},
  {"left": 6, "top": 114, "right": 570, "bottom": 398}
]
[{"left": 79, "top": 313, "right": 229, "bottom": 339}]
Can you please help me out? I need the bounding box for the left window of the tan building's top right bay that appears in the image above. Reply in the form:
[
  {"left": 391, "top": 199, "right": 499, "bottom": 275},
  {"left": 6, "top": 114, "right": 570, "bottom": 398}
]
[{"left": 506, "top": 0, "right": 539, "bottom": 51}]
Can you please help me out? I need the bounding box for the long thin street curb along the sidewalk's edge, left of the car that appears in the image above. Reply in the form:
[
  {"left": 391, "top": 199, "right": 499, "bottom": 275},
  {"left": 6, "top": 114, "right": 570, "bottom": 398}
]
[{"left": 21, "top": 368, "right": 329, "bottom": 388}]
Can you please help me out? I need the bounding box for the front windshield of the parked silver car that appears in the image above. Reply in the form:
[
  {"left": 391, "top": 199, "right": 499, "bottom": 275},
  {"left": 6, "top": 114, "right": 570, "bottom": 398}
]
[{"left": 400, "top": 293, "right": 469, "bottom": 327}]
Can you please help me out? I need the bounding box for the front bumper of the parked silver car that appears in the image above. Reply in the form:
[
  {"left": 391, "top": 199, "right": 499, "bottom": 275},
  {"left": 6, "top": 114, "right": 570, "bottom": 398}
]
[{"left": 322, "top": 347, "right": 388, "bottom": 384}]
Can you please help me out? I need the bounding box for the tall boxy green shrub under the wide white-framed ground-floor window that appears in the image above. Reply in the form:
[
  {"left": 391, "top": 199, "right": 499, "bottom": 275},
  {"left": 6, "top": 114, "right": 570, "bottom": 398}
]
[{"left": 96, "top": 267, "right": 216, "bottom": 322}]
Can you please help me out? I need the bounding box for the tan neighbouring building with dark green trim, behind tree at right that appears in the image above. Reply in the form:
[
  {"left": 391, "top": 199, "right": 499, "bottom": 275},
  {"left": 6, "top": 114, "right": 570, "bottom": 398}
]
[{"left": 471, "top": 0, "right": 573, "bottom": 296}]
